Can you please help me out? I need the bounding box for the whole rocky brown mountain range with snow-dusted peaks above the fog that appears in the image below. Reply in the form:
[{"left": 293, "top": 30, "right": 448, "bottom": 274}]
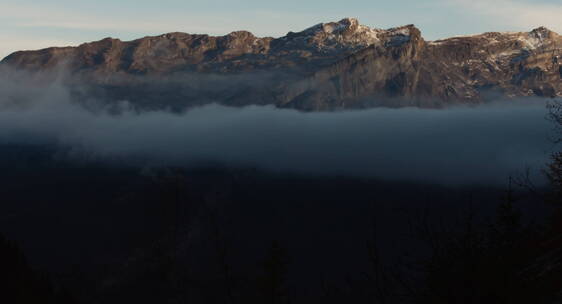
[{"left": 0, "top": 18, "right": 562, "bottom": 111}]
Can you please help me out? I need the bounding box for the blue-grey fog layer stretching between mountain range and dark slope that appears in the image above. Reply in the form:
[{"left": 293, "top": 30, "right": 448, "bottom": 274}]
[{"left": 0, "top": 69, "right": 554, "bottom": 185}]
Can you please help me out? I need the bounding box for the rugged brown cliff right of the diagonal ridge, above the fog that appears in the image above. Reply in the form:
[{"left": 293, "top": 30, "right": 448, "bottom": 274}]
[{"left": 283, "top": 26, "right": 562, "bottom": 109}]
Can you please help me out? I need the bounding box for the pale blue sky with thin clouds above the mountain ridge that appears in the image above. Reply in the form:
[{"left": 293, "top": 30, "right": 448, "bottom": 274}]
[{"left": 0, "top": 0, "right": 562, "bottom": 58}]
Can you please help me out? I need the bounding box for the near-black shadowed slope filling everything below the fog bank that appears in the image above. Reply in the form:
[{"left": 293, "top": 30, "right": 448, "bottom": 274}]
[{"left": 0, "top": 146, "right": 562, "bottom": 304}]
